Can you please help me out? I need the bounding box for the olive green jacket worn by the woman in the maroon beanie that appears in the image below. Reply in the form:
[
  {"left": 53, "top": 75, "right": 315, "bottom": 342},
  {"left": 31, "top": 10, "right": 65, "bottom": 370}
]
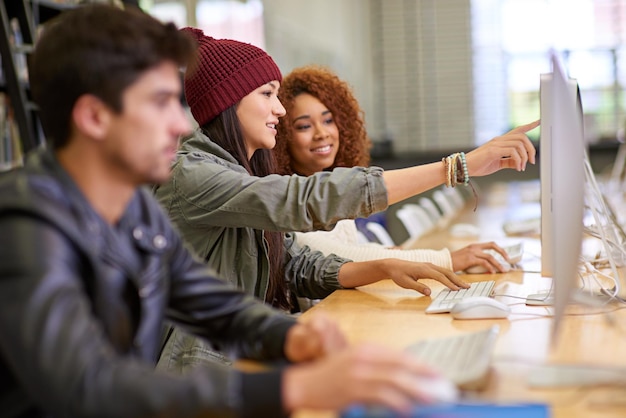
[{"left": 156, "top": 130, "right": 387, "bottom": 299}]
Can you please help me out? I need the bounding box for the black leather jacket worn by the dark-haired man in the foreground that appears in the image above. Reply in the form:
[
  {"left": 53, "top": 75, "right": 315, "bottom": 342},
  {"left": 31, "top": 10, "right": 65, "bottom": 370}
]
[{"left": 0, "top": 150, "right": 294, "bottom": 418}]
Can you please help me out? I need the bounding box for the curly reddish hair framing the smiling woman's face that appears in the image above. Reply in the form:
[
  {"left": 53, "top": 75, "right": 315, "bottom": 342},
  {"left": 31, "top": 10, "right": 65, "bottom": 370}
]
[{"left": 274, "top": 65, "right": 372, "bottom": 174}]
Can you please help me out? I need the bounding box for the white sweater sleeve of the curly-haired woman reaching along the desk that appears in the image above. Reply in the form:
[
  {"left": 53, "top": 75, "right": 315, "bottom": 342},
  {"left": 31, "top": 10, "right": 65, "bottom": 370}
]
[{"left": 295, "top": 220, "right": 452, "bottom": 269}]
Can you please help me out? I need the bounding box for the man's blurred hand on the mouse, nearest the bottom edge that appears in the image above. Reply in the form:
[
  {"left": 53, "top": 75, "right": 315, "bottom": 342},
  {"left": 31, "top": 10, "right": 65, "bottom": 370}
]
[{"left": 282, "top": 345, "right": 437, "bottom": 414}]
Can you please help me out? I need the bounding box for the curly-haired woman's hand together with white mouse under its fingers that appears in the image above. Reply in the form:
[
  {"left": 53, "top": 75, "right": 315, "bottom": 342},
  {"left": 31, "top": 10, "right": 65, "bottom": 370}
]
[{"left": 451, "top": 242, "right": 523, "bottom": 274}]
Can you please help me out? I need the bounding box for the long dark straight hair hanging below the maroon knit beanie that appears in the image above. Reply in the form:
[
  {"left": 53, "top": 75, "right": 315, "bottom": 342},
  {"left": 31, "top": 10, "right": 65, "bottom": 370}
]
[{"left": 201, "top": 105, "right": 291, "bottom": 310}]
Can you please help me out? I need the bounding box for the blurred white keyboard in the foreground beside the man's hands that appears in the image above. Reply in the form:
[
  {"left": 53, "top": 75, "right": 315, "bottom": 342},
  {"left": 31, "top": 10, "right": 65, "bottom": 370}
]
[{"left": 406, "top": 325, "right": 499, "bottom": 390}]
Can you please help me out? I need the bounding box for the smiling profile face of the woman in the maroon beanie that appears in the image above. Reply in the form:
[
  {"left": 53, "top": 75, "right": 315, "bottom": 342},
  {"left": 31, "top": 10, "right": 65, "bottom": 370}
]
[{"left": 237, "top": 80, "right": 286, "bottom": 159}]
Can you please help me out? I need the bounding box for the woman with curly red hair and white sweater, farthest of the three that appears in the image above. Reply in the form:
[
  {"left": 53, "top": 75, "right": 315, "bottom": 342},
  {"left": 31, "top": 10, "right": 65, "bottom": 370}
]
[{"left": 274, "top": 66, "right": 516, "bottom": 273}]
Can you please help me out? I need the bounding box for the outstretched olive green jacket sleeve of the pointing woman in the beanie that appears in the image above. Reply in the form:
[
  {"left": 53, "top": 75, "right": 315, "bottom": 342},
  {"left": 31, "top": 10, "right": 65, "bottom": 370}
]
[{"left": 168, "top": 157, "right": 387, "bottom": 232}]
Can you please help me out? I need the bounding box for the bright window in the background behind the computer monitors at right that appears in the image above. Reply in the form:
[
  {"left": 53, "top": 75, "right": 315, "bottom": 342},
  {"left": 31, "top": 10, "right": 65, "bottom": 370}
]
[{"left": 472, "top": 0, "right": 626, "bottom": 141}]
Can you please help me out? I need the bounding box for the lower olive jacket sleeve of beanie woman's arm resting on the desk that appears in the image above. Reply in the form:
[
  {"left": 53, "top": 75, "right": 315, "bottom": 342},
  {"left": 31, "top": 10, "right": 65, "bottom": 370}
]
[{"left": 284, "top": 234, "right": 351, "bottom": 299}]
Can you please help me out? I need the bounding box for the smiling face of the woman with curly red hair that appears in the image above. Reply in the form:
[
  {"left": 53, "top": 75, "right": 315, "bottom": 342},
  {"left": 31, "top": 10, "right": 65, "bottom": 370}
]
[{"left": 287, "top": 93, "right": 339, "bottom": 176}]
